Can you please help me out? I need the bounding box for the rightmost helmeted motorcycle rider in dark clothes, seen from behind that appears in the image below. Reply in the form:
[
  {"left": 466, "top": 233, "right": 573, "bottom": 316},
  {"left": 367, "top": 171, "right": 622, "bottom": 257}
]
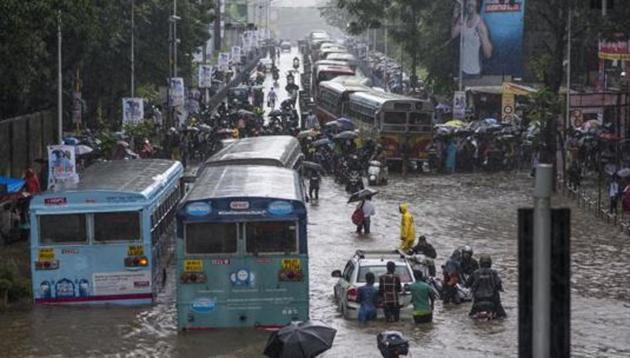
[{"left": 467, "top": 255, "right": 507, "bottom": 318}]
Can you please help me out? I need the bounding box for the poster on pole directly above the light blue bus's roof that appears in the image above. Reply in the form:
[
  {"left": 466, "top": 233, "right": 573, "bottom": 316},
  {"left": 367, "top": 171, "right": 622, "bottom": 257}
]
[{"left": 48, "top": 145, "right": 79, "bottom": 190}]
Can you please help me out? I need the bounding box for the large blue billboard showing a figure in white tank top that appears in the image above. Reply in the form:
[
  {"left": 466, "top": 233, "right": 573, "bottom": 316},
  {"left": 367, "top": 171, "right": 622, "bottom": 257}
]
[{"left": 451, "top": 0, "right": 525, "bottom": 79}]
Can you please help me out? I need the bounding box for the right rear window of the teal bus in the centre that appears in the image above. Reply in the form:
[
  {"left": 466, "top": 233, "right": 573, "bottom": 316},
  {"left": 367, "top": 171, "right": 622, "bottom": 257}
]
[{"left": 246, "top": 221, "right": 297, "bottom": 254}]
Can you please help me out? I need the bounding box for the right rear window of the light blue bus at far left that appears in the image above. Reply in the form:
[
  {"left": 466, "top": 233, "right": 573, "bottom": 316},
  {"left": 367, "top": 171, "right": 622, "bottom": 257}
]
[{"left": 94, "top": 211, "right": 142, "bottom": 242}]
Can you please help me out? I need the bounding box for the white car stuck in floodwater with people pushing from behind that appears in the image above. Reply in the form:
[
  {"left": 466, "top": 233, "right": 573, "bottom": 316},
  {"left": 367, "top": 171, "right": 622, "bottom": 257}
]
[{"left": 332, "top": 250, "right": 415, "bottom": 319}]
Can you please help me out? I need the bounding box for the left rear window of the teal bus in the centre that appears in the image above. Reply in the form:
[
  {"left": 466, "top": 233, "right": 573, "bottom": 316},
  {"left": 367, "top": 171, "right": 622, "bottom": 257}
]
[{"left": 185, "top": 223, "right": 237, "bottom": 255}]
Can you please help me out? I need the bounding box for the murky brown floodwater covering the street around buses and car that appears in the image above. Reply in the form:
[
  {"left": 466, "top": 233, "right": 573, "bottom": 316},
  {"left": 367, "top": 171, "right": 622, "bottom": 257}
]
[{"left": 0, "top": 49, "right": 630, "bottom": 358}]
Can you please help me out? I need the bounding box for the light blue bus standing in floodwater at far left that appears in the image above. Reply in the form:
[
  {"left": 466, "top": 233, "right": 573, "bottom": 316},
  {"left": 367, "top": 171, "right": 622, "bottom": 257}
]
[{"left": 30, "top": 159, "right": 183, "bottom": 305}]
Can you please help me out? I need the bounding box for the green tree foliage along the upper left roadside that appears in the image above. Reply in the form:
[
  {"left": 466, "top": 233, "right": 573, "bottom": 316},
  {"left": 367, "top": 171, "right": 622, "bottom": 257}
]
[{"left": 0, "top": 0, "right": 214, "bottom": 126}]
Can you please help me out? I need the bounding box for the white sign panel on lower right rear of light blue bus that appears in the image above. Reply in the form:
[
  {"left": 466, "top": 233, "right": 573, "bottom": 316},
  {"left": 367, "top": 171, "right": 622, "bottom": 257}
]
[{"left": 92, "top": 271, "right": 151, "bottom": 296}]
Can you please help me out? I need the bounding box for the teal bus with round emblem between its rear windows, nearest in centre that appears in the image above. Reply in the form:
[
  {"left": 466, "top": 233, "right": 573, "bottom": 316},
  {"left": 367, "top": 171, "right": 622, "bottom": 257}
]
[{"left": 176, "top": 165, "right": 309, "bottom": 330}]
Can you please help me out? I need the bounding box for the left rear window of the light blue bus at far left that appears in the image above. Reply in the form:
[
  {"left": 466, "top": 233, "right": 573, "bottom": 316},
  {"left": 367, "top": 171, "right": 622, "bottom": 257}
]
[{"left": 39, "top": 214, "right": 87, "bottom": 245}]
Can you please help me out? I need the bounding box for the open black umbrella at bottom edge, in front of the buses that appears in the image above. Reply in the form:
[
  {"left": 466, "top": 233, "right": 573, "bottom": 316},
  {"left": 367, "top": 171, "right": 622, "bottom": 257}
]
[{"left": 263, "top": 321, "right": 337, "bottom": 358}]
